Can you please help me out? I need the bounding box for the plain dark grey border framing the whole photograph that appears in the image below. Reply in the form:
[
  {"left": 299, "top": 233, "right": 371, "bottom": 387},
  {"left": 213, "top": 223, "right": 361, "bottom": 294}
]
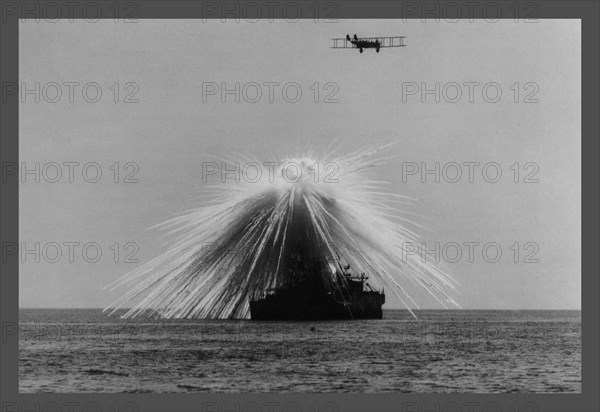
[{"left": 0, "top": 0, "right": 600, "bottom": 412}]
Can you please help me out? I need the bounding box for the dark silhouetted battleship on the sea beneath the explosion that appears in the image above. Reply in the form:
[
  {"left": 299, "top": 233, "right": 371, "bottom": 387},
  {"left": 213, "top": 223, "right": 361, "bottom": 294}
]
[{"left": 250, "top": 260, "right": 385, "bottom": 321}]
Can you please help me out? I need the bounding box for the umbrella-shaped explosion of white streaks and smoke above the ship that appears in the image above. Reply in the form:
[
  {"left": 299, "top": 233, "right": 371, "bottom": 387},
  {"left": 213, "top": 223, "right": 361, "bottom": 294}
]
[{"left": 107, "top": 147, "right": 458, "bottom": 318}]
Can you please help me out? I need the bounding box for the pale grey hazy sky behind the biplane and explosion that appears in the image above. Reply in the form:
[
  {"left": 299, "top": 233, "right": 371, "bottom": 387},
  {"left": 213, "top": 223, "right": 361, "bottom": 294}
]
[{"left": 19, "top": 20, "right": 581, "bottom": 309}]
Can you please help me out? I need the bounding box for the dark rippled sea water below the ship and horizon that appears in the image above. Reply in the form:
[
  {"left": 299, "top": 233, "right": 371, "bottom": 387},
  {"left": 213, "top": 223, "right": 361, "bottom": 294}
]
[{"left": 19, "top": 309, "right": 581, "bottom": 393}]
